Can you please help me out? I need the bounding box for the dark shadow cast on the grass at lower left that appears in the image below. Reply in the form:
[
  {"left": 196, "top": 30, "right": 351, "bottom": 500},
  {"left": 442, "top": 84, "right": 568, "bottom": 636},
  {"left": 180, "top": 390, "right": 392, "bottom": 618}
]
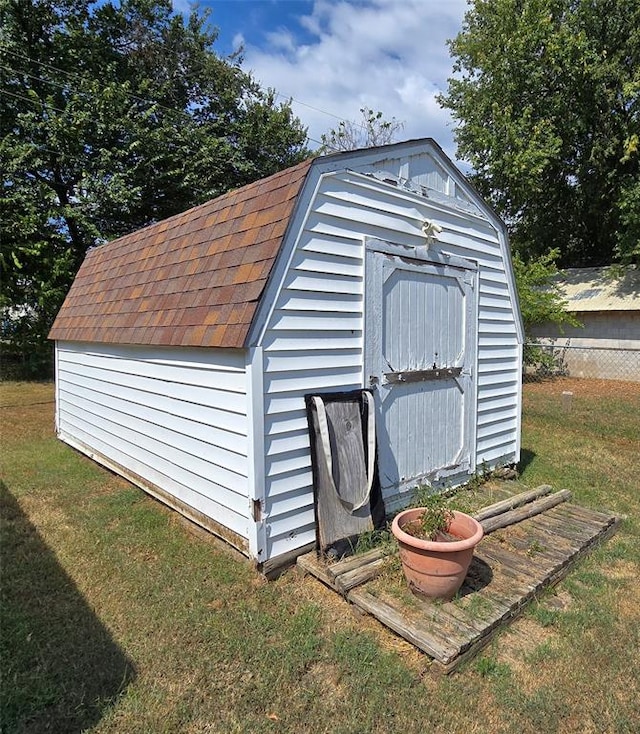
[{"left": 0, "top": 482, "right": 135, "bottom": 734}]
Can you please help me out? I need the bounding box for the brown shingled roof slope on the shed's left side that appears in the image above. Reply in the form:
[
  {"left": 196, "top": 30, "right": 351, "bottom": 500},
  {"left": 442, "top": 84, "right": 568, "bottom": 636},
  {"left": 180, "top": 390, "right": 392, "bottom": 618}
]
[{"left": 49, "top": 161, "right": 311, "bottom": 347}]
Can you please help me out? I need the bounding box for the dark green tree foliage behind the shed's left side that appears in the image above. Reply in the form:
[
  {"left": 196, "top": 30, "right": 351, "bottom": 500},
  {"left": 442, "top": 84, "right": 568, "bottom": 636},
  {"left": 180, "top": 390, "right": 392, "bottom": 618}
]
[{"left": 0, "top": 0, "right": 308, "bottom": 376}]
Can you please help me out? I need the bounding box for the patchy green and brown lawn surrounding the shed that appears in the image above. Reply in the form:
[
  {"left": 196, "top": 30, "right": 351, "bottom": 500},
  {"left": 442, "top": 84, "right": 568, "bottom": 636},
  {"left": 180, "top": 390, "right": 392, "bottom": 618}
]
[{"left": 0, "top": 381, "right": 640, "bottom": 734}]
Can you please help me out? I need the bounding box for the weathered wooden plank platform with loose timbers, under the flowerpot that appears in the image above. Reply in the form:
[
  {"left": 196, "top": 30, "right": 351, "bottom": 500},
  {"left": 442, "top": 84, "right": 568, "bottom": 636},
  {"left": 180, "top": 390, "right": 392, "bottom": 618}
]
[{"left": 298, "top": 486, "right": 619, "bottom": 673}]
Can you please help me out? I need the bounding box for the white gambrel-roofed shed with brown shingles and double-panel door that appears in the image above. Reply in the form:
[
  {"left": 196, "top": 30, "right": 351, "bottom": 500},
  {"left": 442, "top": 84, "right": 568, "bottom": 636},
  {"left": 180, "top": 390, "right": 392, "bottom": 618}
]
[{"left": 50, "top": 139, "right": 523, "bottom": 572}]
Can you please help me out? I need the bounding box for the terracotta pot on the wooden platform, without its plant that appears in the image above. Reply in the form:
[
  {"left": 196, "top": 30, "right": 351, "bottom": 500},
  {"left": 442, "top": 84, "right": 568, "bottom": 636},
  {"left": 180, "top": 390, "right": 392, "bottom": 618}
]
[{"left": 391, "top": 507, "right": 483, "bottom": 599}]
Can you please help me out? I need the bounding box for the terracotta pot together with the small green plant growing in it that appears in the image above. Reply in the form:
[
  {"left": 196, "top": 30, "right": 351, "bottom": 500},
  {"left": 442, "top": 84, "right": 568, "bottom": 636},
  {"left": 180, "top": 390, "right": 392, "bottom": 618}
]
[{"left": 391, "top": 494, "right": 483, "bottom": 599}]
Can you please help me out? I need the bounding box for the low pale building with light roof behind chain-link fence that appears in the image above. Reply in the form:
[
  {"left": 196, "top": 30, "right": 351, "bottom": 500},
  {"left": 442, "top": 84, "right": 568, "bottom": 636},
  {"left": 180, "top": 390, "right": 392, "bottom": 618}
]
[{"left": 531, "top": 265, "right": 640, "bottom": 381}]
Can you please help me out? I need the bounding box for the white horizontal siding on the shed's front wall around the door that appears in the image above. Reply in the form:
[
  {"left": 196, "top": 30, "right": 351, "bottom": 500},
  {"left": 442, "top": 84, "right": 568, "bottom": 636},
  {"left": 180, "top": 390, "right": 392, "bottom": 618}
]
[{"left": 261, "top": 172, "right": 520, "bottom": 558}]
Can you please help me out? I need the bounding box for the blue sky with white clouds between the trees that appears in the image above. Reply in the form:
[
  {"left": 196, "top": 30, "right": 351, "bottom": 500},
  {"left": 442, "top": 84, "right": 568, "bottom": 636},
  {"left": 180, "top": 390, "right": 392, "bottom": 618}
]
[{"left": 188, "top": 0, "right": 467, "bottom": 159}]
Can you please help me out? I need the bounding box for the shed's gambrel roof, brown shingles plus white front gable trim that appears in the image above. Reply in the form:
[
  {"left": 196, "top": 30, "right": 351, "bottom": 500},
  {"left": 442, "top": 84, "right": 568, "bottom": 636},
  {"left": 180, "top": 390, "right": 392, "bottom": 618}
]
[{"left": 49, "top": 138, "right": 522, "bottom": 348}]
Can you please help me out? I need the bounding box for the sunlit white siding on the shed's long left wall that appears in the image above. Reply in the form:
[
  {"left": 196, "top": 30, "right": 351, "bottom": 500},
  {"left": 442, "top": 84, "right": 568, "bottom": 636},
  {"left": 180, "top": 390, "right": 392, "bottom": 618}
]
[{"left": 56, "top": 342, "right": 249, "bottom": 538}]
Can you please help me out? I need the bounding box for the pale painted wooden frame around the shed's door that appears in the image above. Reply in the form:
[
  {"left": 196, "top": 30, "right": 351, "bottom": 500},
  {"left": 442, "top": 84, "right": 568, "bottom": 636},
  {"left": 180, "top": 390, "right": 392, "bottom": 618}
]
[{"left": 363, "top": 237, "right": 478, "bottom": 493}]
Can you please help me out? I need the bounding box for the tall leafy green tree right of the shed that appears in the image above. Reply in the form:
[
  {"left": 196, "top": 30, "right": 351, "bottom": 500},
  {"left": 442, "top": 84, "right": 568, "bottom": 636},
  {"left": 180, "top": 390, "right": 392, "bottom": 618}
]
[{"left": 440, "top": 0, "right": 640, "bottom": 266}]
